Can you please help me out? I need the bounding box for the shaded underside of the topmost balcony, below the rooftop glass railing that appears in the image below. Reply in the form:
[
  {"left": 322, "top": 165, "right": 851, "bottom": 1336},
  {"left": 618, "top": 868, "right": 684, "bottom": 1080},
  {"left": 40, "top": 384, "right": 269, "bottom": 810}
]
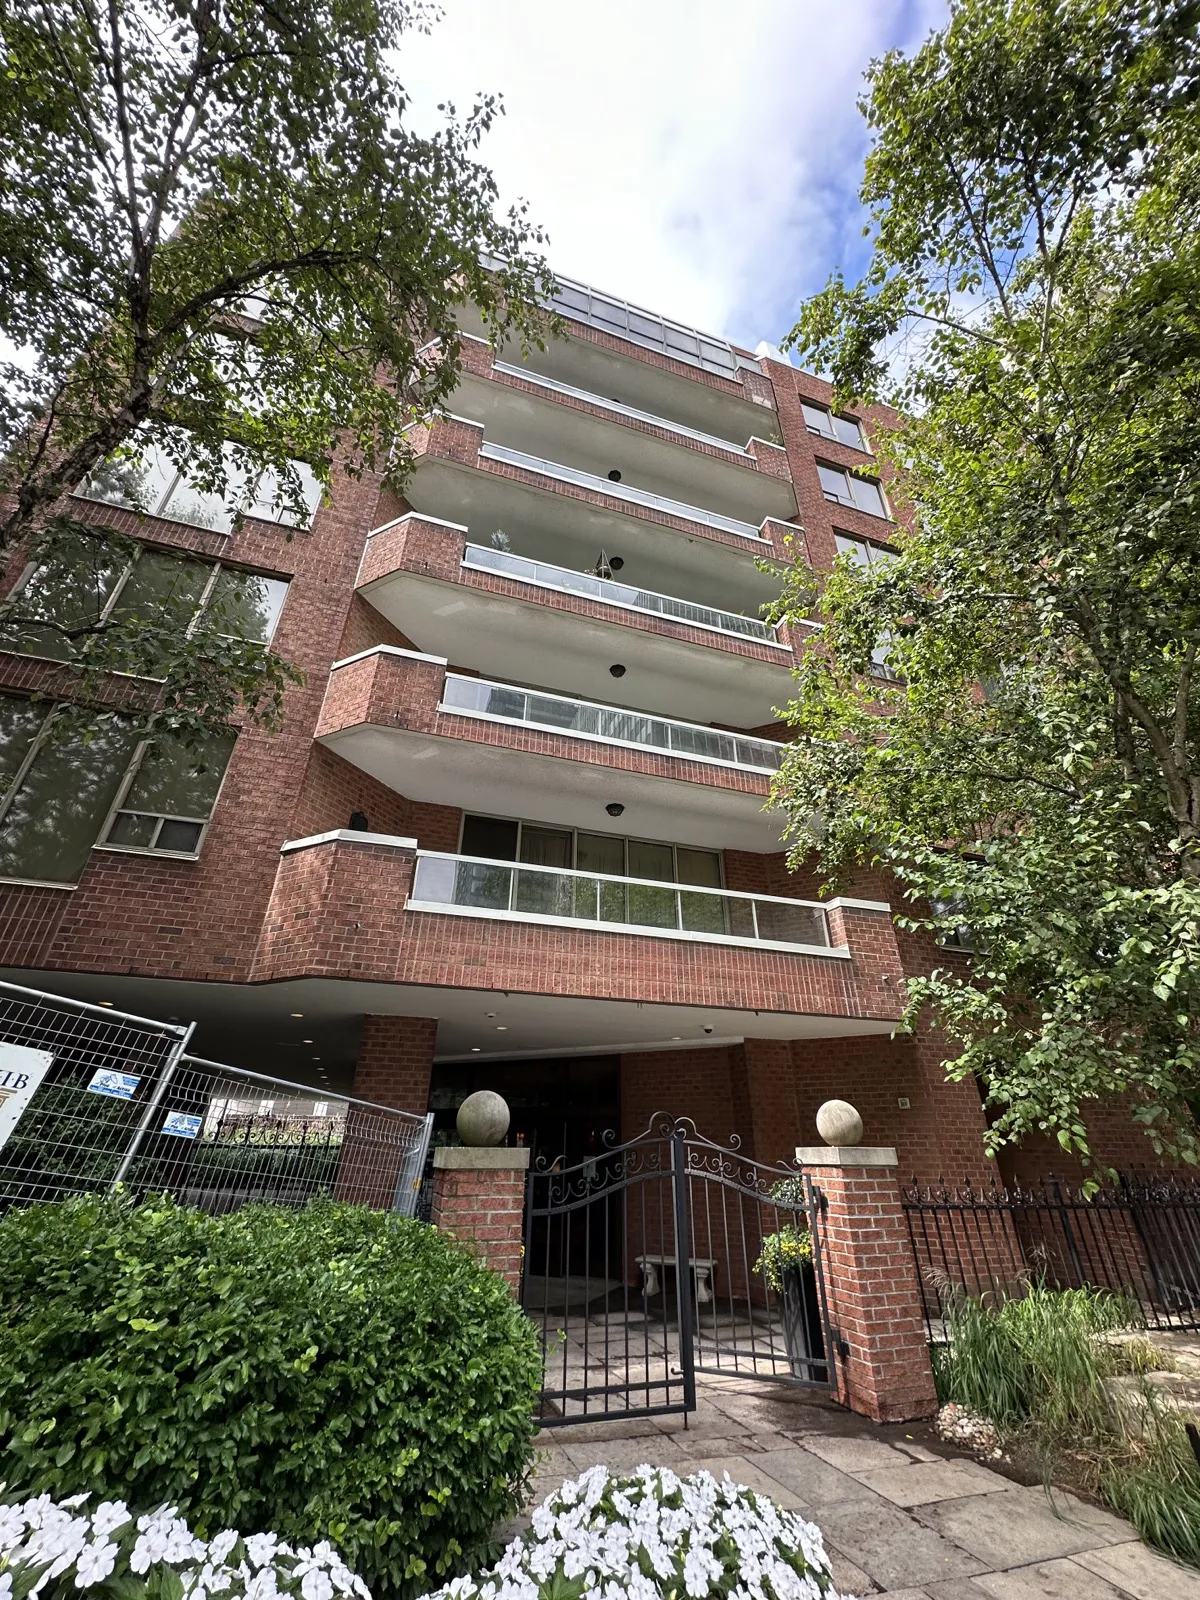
[{"left": 458, "top": 307, "right": 781, "bottom": 443}]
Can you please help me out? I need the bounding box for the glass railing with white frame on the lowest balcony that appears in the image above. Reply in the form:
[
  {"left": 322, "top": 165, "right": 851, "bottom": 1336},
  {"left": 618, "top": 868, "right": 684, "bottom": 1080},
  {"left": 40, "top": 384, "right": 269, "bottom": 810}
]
[{"left": 411, "top": 850, "right": 830, "bottom": 949}]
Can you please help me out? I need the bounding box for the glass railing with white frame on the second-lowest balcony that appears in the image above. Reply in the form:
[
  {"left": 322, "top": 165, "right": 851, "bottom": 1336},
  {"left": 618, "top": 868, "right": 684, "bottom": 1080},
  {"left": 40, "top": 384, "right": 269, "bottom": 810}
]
[{"left": 438, "top": 672, "right": 784, "bottom": 773}]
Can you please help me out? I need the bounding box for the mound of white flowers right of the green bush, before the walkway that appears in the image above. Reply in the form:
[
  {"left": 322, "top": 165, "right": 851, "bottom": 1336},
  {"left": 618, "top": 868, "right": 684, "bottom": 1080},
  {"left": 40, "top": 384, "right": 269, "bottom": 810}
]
[{"left": 427, "top": 1467, "right": 837, "bottom": 1600}]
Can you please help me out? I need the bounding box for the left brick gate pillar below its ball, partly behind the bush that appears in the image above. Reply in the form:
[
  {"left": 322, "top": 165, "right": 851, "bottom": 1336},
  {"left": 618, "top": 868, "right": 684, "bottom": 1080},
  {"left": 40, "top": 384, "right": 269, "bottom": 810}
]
[{"left": 432, "top": 1144, "right": 530, "bottom": 1293}]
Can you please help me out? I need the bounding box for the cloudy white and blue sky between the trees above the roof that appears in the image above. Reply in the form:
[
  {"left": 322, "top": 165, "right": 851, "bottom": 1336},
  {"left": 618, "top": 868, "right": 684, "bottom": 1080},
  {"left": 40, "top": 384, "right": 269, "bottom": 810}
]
[{"left": 400, "top": 0, "right": 944, "bottom": 347}]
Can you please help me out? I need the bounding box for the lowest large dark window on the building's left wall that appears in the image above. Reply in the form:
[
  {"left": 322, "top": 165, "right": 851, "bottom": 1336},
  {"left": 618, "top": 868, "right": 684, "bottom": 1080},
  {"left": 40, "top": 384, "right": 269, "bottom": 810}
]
[{"left": 0, "top": 696, "right": 234, "bottom": 885}]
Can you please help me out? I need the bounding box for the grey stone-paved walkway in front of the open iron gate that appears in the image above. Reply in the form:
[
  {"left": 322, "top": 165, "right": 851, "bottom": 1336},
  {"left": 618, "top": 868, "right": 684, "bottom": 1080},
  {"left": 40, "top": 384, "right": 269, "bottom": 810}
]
[{"left": 531, "top": 1378, "right": 1200, "bottom": 1600}]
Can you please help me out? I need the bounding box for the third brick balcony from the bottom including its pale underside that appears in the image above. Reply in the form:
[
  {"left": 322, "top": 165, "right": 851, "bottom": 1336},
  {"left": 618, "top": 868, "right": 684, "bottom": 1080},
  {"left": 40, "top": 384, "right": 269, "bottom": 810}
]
[{"left": 358, "top": 512, "right": 795, "bottom": 728}]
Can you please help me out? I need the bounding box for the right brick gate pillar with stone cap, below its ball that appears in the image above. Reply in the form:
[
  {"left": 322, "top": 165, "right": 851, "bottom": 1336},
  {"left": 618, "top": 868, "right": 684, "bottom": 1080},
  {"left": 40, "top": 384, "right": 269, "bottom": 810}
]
[{"left": 795, "top": 1146, "right": 938, "bottom": 1422}]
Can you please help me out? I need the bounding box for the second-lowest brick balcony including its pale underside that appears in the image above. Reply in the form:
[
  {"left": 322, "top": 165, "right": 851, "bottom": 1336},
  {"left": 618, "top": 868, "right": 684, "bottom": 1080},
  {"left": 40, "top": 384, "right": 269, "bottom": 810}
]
[{"left": 317, "top": 645, "right": 793, "bottom": 851}]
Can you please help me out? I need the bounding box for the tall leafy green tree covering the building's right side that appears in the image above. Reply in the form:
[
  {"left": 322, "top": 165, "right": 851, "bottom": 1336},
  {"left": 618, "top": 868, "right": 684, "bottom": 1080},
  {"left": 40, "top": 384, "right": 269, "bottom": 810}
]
[{"left": 779, "top": 0, "right": 1200, "bottom": 1158}]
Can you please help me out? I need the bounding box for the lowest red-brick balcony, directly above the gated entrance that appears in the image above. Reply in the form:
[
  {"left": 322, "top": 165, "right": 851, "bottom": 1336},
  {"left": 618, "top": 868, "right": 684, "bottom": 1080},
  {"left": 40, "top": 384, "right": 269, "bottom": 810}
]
[{"left": 250, "top": 832, "right": 902, "bottom": 1059}]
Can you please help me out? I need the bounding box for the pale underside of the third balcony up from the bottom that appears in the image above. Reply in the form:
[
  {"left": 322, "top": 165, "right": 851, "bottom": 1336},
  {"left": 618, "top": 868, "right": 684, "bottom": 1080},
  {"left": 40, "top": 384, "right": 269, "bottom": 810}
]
[{"left": 360, "top": 570, "right": 792, "bottom": 728}]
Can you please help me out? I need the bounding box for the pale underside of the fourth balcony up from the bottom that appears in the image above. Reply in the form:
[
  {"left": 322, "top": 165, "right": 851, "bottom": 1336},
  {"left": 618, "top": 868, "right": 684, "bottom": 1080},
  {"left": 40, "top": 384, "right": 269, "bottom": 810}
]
[{"left": 405, "top": 456, "right": 779, "bottom": 616}]
